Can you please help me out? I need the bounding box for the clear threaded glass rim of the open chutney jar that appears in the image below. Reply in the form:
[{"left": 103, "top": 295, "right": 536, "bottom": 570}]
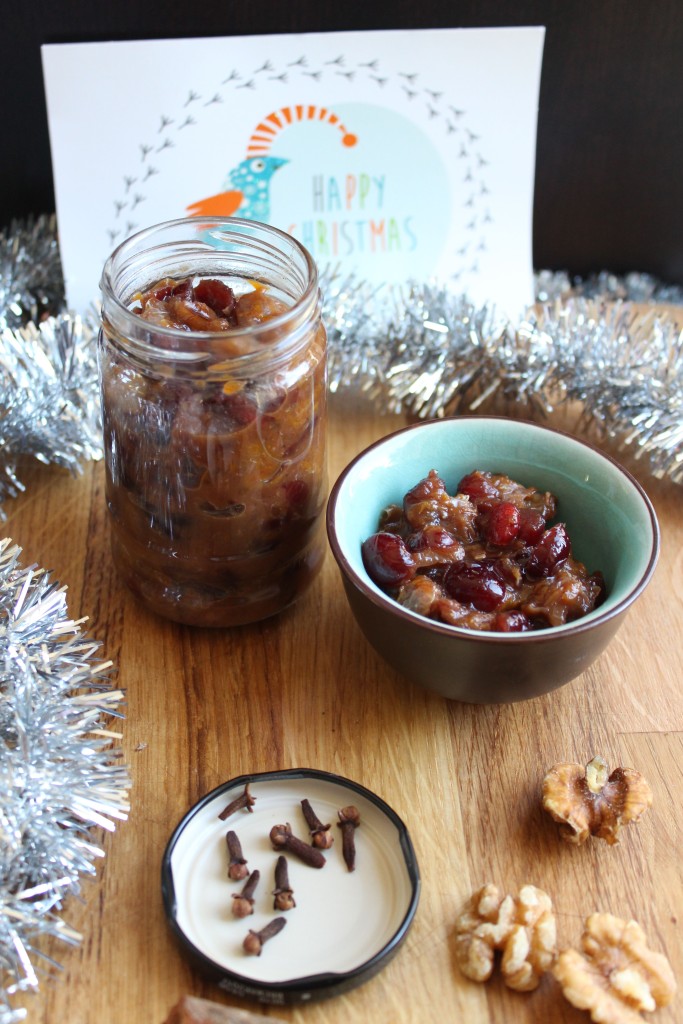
[{"left": 99, "top": 217, "right": 321, "bottom": 359}]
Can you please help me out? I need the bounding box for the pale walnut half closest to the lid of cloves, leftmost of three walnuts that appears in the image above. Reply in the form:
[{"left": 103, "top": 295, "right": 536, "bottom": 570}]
[{"left": 455, "top": 883, "right": 556, "bottom": 992}]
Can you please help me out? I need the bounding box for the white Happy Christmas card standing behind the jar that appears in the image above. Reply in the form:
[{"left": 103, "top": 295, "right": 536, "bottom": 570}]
[{"left": 42, "top": 28, "right": 545, "bottom": 315}]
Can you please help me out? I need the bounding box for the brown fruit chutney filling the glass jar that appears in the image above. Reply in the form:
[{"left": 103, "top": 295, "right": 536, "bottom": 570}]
[{"left": 101, "top": 268, "right": 327, "bottom": 627}]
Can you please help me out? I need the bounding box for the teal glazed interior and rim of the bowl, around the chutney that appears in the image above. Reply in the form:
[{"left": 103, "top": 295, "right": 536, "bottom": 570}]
[{"left": 328, "top": 417, "right": 659, "bottom": 640}]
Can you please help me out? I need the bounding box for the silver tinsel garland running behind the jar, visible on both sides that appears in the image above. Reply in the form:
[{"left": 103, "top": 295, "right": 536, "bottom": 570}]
[{"left": 0, "top": 218, "right": 683, "bottom": 509}]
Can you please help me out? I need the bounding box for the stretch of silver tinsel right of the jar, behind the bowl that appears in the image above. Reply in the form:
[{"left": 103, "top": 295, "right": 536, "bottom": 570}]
[{"left": 326, "top": 273, "right": 683, "bottom": 483}]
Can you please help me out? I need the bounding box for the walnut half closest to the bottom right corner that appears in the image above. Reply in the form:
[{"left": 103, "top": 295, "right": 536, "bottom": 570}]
[{"left": 552, "top": 913, "right": 676, "bottom": 1024}]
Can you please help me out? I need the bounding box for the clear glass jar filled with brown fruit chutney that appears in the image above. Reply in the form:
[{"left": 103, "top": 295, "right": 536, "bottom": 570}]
[{"left": 98, "top": 217, "right": 327, "bottom": 627}]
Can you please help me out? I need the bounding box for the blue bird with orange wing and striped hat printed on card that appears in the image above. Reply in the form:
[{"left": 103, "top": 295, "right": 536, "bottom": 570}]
[{"left": 186, "top": 104, "right": 357, "bottom": 221}]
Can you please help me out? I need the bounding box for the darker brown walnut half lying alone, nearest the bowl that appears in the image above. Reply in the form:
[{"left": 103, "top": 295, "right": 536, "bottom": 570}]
[{"left": 543, "top": 757, "right": 652, "bottom": 844}]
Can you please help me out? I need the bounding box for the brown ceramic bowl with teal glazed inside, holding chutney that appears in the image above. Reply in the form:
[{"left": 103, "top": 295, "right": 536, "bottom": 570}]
[{"left": 327, "top": 416, "right": 659, "bottom": 703}]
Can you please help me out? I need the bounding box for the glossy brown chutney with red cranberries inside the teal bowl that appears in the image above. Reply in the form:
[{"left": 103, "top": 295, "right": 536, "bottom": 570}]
[{"left": 362, "top": 469, "right": 605, "bottom": 633}]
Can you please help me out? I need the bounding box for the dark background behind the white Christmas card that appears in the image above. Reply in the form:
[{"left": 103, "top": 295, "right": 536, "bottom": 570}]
[{"left": 5, "top": 0, "right": 683, "bottom": 285}]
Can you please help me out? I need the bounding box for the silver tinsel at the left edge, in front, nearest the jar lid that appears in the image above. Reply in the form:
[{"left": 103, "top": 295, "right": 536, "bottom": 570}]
[{"left": 0, "top": 539, "right": 130, "bottom": 1024}]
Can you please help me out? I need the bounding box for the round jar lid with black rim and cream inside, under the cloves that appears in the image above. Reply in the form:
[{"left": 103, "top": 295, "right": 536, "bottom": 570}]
[{"left": 162, "top": 768, "right": 420, "bottom": 1006}]
